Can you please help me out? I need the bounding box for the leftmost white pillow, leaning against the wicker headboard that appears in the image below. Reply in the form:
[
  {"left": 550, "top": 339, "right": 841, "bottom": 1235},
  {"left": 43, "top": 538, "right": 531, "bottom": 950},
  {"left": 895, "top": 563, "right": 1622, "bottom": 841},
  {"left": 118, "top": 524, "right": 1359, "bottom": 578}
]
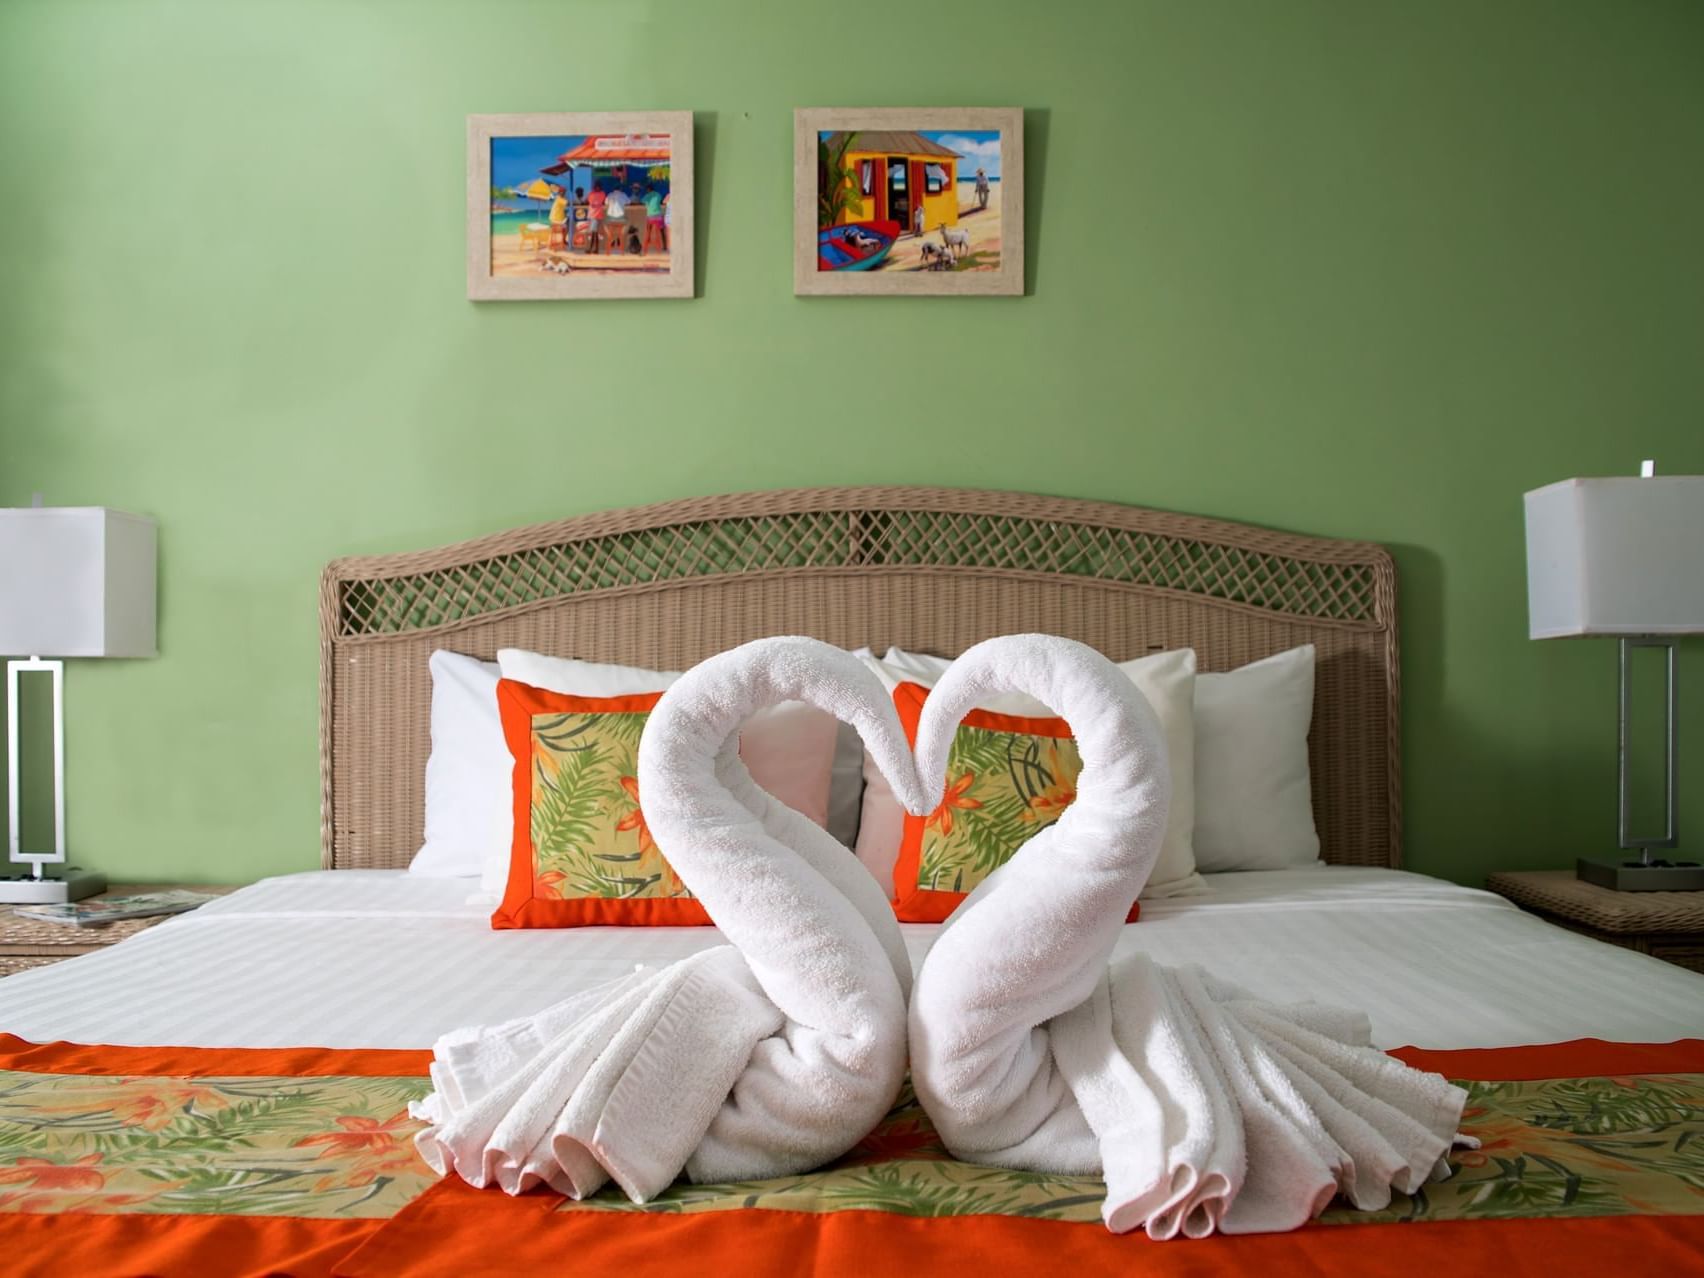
[{"left": 409, "top": 661, "right": 515, "bottom": 878}]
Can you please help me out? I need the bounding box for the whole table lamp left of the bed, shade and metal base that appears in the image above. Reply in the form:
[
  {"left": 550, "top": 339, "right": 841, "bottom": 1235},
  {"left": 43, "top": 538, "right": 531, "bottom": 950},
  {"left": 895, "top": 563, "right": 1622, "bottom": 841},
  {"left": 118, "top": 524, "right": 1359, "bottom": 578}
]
[{"left": 0, "top": 498, "right": 155, "bottom": 903}]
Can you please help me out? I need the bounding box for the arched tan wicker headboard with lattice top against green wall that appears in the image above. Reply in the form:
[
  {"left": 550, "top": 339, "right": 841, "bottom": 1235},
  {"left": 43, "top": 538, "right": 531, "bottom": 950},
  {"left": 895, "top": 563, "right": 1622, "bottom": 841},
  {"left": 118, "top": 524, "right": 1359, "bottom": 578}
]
[{"left": 320, "top": 487, "right": 1401, "bottom": 869}]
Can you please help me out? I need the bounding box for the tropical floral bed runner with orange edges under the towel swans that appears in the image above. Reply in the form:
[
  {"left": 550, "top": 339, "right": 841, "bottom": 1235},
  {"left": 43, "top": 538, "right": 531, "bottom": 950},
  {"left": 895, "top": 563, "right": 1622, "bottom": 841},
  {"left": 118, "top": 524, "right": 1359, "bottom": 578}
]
[{"left": 0, "top": 1036, "right": 1704, "bottom": 1278}]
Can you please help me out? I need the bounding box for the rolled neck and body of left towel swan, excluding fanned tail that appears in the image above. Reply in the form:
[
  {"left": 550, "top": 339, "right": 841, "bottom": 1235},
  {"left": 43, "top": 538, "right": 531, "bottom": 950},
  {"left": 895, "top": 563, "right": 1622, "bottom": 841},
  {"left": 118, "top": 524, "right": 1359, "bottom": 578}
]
[{"left": 639, "top": 637, "right": 930, "bottom": 1179}]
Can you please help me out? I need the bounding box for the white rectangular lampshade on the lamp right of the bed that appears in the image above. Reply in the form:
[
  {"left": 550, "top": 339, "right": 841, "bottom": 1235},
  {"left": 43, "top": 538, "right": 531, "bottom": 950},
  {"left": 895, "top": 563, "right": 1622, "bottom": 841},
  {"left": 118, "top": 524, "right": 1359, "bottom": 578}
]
[{"left": 1527, "top": 475, "right": 1704, "bottom": 639}]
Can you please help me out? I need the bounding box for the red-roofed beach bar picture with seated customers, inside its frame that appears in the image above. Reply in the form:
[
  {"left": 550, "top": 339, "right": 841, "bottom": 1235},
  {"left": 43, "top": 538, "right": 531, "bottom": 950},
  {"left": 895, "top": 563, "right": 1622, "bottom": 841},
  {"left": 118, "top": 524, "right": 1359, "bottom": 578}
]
[{"left": 491, "top": 133, "right": 671, "bottom": 276}]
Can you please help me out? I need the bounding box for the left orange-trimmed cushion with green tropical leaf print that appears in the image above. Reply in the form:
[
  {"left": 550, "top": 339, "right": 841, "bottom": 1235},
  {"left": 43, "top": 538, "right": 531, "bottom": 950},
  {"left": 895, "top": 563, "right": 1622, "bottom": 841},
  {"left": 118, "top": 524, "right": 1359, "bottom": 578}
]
[{"left": 491, "top": 678, "right": 711, "bottom": 927}]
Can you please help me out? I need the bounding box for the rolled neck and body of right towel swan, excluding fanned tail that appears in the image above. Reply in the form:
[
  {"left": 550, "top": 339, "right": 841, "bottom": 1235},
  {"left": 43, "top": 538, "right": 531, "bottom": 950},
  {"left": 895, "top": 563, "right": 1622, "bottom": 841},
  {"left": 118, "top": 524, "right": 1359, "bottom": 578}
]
[{"left": 910, "top": 636, "right": 1171, "bottom": 1172}]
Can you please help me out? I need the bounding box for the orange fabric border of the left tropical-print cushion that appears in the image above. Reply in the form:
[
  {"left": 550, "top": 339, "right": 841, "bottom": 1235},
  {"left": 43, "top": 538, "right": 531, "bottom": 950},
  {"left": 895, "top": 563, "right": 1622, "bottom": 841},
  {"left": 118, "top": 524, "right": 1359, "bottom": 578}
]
[{"left": 491, "top": 678, "right": 711, "bottom": 930}]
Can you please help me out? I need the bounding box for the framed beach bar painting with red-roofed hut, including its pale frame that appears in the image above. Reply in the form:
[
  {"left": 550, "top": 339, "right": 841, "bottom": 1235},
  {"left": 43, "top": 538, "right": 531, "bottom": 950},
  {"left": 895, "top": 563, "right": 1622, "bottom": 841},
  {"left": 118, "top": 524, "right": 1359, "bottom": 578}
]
[{"left": 467, "top": 111, "right": 692, "bottom": 300}]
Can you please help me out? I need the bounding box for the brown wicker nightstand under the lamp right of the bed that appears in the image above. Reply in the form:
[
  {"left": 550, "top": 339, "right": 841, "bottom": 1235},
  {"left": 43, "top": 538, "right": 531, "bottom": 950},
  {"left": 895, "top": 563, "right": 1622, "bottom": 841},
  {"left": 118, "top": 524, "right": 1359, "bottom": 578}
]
[{"left": 1486, "top": 869, "right": 1704, "bottom": 973}]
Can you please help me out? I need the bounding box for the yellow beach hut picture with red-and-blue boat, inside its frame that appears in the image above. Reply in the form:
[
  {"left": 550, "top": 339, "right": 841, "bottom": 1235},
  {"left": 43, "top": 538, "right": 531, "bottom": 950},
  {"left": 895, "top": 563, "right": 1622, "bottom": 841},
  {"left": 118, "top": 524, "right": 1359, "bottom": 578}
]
[{"left": 816, "top": 130, "right": 1000, "bottom": 271}]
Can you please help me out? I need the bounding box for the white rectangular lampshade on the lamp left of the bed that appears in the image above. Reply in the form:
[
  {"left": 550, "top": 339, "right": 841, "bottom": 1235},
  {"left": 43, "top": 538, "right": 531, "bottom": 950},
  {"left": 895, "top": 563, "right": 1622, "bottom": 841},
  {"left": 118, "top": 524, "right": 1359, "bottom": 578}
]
[{"left": 0, "top": 506, "right": 155, "bottom": 658}]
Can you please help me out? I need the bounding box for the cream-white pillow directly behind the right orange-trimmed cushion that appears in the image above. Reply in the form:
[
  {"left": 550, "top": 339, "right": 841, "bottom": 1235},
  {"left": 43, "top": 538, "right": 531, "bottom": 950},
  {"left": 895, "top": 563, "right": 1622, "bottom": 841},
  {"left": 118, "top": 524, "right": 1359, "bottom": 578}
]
[{"left": 857, "top": 648, "right": 1206, "bottom": 900}]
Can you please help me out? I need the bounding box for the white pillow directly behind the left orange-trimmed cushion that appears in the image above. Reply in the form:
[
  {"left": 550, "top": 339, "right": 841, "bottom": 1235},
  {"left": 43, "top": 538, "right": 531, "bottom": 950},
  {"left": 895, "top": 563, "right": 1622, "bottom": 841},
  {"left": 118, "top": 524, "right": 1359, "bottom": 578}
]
[{"left": 481, "top": 648, "right": 838, "bottom": 893}]
